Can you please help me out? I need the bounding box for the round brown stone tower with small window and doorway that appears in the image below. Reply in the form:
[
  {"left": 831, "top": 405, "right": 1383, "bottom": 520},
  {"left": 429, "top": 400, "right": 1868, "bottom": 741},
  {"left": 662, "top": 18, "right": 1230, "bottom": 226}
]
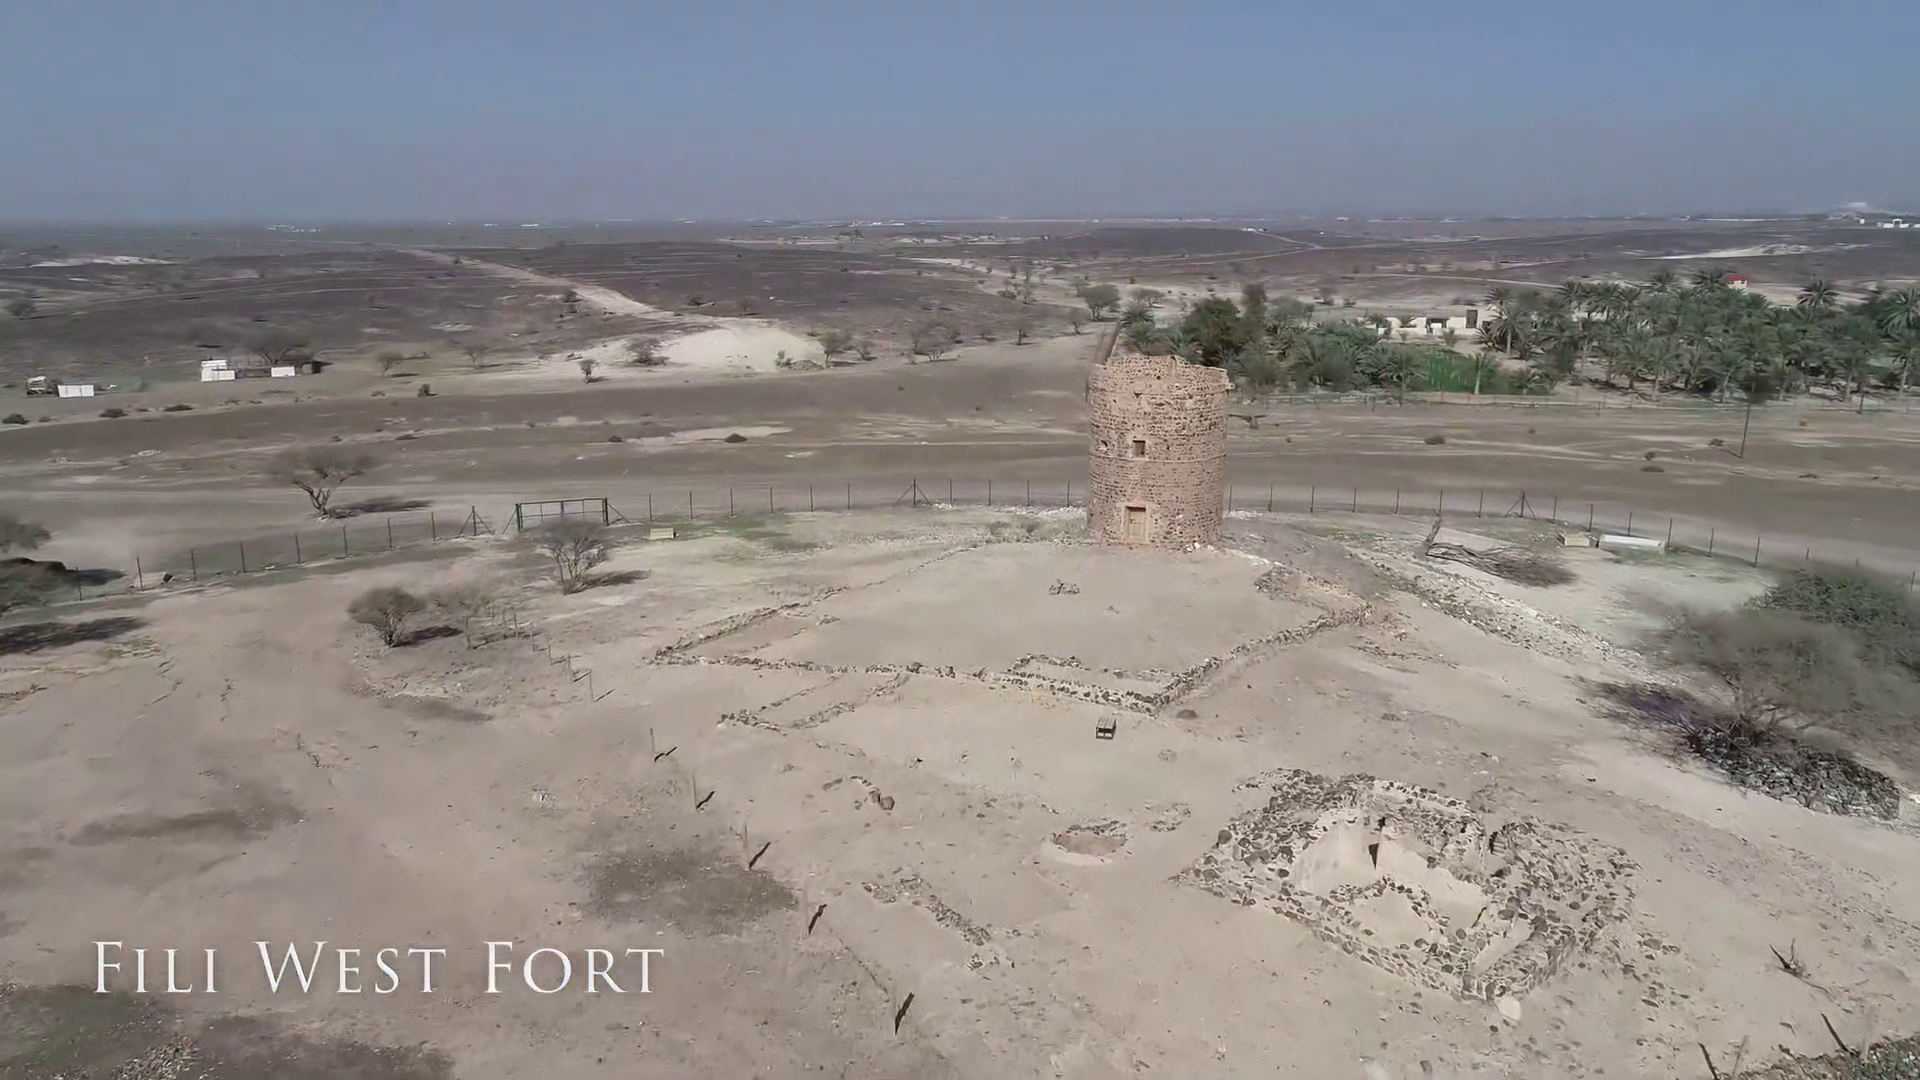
[{"left": 1087, "top": 354, "right": 1229, "bottom": 550}]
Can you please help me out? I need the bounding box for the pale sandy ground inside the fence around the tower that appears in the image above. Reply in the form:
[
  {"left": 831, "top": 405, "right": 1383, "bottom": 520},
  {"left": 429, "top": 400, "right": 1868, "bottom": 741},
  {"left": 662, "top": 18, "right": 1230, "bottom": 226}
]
[{"left": 0, "top": 511, "right": 1920, "bottom": 1078}]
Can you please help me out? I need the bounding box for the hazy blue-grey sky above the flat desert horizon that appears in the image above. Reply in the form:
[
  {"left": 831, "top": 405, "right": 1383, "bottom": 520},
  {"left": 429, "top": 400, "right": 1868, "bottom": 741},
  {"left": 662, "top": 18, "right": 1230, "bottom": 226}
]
[{"left": 0, "top": 0, "right": 1920, "bottom": 223}]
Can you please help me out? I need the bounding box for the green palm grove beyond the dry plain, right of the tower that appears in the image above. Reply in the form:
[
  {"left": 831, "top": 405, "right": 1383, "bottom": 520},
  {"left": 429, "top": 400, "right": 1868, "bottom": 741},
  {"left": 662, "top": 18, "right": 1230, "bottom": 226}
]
[{"left": 1087, "top": 269, "right": 1920, "bottom": 405}]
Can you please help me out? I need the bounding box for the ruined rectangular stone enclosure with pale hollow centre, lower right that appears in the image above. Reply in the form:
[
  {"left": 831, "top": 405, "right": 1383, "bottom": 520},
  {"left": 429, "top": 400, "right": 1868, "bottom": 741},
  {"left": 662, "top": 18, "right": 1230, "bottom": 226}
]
[{"left": 1175, "top": 769, "right": 1636, "bottom": 1001}]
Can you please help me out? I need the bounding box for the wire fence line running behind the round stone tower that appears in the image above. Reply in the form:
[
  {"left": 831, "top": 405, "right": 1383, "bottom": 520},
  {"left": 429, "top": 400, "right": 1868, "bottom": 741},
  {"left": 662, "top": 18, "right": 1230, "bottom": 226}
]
[{"left": 56, "top": 477, "right": 1920, "bottom": 600}]
